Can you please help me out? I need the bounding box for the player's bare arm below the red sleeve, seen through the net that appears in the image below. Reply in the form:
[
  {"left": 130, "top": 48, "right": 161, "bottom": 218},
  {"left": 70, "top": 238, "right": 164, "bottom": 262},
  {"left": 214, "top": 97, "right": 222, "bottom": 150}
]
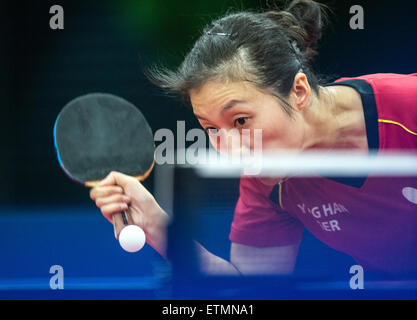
[{"left": 196, "top": 242, "right": 299, "bottom": 275}]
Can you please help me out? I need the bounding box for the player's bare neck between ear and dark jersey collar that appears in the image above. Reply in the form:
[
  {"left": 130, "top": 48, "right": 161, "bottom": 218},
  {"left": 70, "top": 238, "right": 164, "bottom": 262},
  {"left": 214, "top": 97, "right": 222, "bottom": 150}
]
[{"left": 306, "top": 86, "right": 368, "bottom": 151}]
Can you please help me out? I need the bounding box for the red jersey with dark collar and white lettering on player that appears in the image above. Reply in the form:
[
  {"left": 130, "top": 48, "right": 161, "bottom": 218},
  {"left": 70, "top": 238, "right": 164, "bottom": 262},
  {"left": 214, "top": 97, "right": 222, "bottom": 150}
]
[{"left": 229, "top": 73, "right": 417, "bottom": 273}]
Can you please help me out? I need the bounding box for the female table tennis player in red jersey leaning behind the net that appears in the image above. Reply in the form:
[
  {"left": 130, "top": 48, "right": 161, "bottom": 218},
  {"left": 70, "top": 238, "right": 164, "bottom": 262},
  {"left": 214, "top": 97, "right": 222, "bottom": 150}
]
[{"left": 91, "top": 0, "right": 417, "bottom": 274}]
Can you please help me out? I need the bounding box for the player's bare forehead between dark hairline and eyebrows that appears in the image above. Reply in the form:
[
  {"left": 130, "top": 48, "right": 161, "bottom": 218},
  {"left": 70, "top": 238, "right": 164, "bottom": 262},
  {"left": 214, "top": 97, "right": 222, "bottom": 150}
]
[{"left": 189, "top": 81, "right": 260, "bottom": 113}]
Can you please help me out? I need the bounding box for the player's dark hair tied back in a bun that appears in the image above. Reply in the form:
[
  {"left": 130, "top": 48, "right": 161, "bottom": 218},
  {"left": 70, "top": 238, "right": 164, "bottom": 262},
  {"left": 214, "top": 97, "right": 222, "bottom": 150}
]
[{"left": 147, "top": 0, "right": 325, "bottom": 115}]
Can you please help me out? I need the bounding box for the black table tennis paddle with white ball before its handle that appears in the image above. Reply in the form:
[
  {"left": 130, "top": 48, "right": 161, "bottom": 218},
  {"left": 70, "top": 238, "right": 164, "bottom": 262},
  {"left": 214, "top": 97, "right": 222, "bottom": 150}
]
[{"left": 54, "top": 93, "right": 155, "bottom": 252}]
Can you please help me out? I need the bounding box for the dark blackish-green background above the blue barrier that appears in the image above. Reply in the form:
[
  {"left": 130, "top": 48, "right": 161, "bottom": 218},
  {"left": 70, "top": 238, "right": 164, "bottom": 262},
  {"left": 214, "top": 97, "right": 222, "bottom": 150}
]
[{"left": 0, "top": 0, "right": 417, "bottom": 205}]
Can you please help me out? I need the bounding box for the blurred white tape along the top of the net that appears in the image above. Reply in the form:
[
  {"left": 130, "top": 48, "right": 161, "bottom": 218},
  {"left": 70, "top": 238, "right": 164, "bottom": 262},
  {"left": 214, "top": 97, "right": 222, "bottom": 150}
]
[{"left": 177, "top": 150, "right": 417, "bottom": 178}]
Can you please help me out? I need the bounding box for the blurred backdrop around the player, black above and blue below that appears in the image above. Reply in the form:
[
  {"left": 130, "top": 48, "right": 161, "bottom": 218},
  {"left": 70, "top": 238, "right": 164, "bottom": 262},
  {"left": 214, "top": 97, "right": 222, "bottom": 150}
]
[{"left": 0, "top": 0, "right": 417, "bottom": 298}]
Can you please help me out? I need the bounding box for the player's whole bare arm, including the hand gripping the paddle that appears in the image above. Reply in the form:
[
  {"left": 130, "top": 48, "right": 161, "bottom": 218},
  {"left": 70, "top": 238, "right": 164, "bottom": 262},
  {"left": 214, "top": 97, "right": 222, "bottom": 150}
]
[{"left": 90, "top": 172, "right": 298, "bottom": 275}]
